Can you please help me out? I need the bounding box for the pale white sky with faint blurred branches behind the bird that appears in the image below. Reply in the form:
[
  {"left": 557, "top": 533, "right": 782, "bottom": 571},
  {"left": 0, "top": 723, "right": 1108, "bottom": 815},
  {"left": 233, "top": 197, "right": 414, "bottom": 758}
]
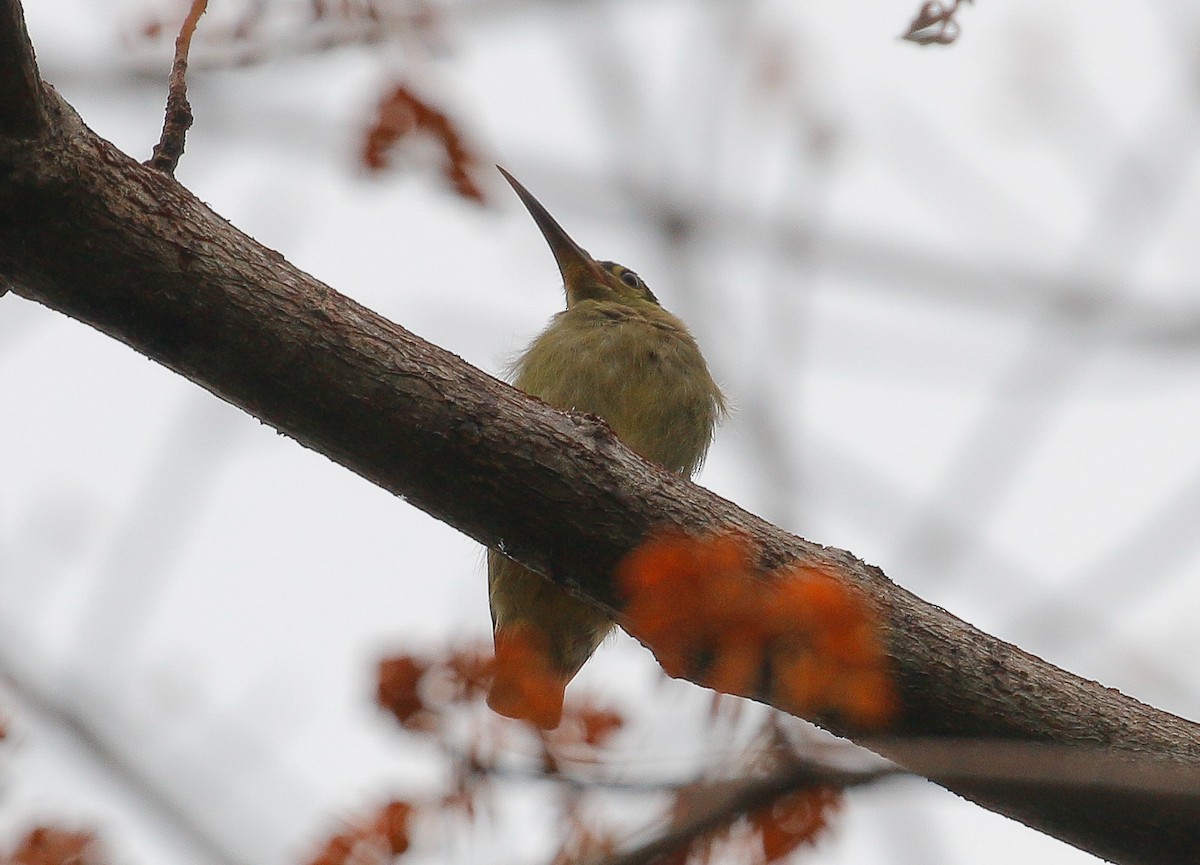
[{"left": 0, "top": 0, "right": 1200, "bottom": 865}]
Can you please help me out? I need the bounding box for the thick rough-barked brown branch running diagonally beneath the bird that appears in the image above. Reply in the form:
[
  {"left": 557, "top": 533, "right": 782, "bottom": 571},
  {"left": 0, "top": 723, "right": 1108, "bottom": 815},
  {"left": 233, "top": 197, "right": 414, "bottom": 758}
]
[{"left": 0, "top": 0, "right": 1200, "bottom": 864}]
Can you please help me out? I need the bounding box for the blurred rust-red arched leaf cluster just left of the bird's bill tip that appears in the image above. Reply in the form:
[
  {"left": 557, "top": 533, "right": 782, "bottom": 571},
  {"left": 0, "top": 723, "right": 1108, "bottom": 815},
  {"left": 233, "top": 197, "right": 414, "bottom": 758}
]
[{"left": 362, "top": 84, "right": 484, "bottom": 204}]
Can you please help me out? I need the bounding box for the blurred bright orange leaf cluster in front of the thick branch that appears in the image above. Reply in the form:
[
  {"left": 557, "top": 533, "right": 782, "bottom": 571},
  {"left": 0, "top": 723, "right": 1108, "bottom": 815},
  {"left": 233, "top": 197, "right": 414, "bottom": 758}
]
[{"left": 617, "top": 533, "right": 896, "bottom": 727}]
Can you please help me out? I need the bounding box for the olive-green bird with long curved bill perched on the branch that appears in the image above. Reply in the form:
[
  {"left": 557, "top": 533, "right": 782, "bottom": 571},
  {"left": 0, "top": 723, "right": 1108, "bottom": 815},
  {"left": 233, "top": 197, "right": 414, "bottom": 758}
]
[{"left": 487, "top": 168, "right": 725, "bottom": 727}]
